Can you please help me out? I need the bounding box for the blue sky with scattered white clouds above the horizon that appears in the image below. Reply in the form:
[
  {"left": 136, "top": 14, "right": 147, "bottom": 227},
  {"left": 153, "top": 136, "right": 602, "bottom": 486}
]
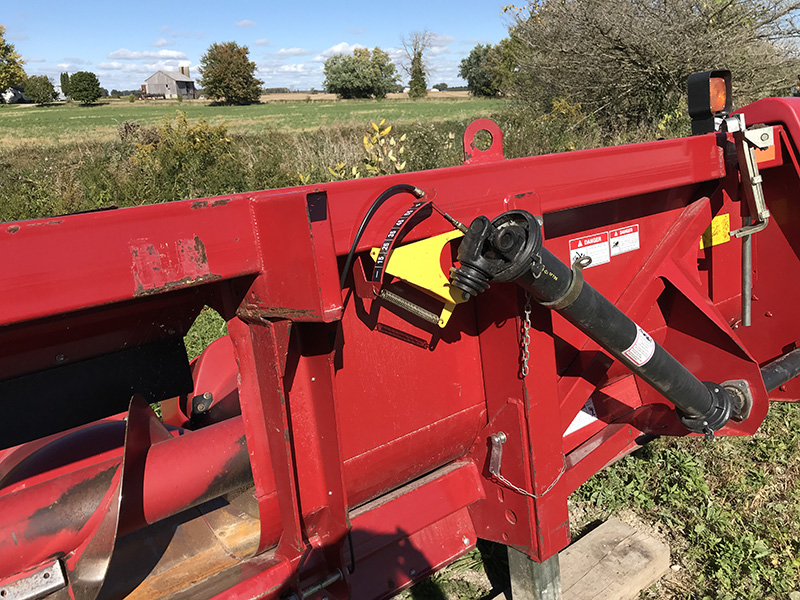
[{"left": 0, "top": 0, "right": 508, "bottom": 90}]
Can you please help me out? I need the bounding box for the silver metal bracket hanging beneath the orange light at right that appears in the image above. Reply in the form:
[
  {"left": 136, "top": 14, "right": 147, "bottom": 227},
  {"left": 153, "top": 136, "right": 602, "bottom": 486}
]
[{"left": 725, "top": 114, "right": 775, "bottom": 238}]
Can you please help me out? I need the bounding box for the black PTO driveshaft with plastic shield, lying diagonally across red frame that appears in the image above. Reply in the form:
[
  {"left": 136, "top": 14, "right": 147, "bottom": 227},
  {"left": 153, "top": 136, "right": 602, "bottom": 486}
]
[{"left": 450, "top": 210, "right": 748, "bottom": 436}]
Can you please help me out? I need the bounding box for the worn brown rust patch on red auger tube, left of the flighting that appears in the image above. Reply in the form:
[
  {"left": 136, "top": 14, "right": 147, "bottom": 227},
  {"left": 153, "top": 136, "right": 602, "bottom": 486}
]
[{"left": 25, "top": 464, "right": 120, "bottom": 540}]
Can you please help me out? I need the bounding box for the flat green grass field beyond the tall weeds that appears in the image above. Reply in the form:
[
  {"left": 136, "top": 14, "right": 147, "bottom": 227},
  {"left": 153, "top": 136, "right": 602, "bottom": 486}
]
[{"left": 0, "top": 96, "right": 505, "bottom": 148}]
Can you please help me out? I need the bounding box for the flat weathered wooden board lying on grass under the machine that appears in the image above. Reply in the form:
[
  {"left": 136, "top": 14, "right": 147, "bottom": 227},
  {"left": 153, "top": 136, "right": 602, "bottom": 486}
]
[{"left": 560, "top": 518, "right": 669, "bottom": 600}]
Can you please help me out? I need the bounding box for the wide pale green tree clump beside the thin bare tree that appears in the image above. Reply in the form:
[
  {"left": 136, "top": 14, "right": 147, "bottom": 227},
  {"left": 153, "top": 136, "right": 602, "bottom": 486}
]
[{"left": 323, "top": 46, "right": 397, "bottom": 99}]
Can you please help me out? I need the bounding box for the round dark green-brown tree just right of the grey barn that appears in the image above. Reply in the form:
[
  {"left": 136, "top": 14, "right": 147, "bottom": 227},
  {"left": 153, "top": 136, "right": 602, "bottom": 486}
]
[{"left": 200, "top": 42, "right": 264, "bottom": 104}]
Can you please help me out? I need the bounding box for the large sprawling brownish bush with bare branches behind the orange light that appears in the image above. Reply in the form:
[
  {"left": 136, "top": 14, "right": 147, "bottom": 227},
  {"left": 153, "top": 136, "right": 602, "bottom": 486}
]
[{"left": 510, "top": 0, "right": 800, "bottom": 124}]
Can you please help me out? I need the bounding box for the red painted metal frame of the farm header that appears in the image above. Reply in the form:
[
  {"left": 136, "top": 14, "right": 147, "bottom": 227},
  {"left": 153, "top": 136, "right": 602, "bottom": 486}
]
[{"left": 0, "top": 99, "right": 800, "bottom": 598}]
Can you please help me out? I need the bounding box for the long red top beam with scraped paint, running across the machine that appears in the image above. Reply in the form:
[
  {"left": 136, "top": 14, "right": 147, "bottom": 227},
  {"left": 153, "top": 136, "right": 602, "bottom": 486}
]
[{"left": 0, "top": 135, "right": 725, "bottom": 325}]
